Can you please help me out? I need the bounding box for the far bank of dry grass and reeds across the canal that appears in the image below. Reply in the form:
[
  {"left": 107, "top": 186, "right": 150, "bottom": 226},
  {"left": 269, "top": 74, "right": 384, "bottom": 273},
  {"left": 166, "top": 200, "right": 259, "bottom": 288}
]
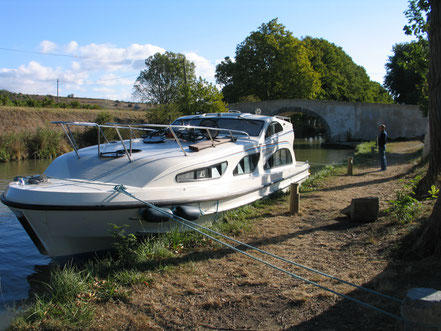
[{"left": 0, "top": 106, "right": 145, "bottom": 161}]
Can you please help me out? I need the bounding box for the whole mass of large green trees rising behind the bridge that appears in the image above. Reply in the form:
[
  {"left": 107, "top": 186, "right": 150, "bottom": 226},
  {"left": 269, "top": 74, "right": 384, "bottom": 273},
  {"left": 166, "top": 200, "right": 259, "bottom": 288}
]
[{"left": 216, "top": 19, "right": 392, "bottom": 102}]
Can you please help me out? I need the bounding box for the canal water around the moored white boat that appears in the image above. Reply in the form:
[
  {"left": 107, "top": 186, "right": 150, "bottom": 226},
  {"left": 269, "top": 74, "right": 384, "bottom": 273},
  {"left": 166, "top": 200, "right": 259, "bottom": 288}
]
[{"left": 0, "top": 143, "right": 352, "bottom": 320}]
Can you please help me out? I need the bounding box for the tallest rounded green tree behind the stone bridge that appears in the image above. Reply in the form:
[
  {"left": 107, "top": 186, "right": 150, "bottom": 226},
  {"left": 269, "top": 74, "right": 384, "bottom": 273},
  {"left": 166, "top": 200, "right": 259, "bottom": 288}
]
[{"left": 216, "top": 19, "right": 320, "bottom": 102}]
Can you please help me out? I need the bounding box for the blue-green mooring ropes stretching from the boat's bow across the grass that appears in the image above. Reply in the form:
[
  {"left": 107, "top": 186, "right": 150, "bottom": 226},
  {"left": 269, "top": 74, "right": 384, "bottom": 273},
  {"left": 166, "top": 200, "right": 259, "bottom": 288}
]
[{"left": 114, "top": 185, "right": 407, "bottom": 322}]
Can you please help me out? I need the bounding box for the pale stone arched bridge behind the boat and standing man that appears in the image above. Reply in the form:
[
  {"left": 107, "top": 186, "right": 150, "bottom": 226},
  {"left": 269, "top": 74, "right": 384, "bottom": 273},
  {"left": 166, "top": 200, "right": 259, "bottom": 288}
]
[{"left": 229, "top": 99, "right": 427, "bottom": 142}]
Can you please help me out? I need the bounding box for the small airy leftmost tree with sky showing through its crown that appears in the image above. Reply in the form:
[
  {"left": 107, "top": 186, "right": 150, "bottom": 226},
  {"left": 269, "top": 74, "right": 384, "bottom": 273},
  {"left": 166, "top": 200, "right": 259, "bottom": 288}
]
[{"left": 133, "top": 52, "right": 196, "bottom": 105}]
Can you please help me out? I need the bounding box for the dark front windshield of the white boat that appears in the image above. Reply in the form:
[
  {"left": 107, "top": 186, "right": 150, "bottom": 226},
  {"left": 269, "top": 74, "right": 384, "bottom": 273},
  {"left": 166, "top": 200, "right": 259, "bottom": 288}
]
[{"left": 173, "top": 117, "right": 265, "bottom": 137}]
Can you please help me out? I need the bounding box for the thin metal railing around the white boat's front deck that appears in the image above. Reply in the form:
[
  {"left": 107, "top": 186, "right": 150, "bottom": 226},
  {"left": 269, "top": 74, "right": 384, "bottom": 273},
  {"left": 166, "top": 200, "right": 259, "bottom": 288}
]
[{"left": 51, "top": 121, "right": 251, "bottom": 162}]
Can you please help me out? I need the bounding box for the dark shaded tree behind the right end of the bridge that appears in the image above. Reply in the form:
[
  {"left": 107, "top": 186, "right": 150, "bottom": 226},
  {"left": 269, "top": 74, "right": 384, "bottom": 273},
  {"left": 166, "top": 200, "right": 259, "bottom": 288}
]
[{"left": 384, "top": 38, "right": 429, "bottom": 114}]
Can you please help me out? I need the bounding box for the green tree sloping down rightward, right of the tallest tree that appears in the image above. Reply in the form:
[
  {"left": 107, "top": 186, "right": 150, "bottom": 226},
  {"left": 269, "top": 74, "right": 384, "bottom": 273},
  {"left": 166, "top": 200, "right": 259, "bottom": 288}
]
[{"left": 302, "top": 37, "right": 392, "bottom": 103}]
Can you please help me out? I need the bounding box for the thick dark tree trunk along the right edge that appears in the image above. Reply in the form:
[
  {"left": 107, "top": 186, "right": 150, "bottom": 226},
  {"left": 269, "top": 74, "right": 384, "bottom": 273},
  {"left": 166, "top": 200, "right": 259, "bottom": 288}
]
[{"left": 413, "top": 0, "right": 441, "bottom": 256}]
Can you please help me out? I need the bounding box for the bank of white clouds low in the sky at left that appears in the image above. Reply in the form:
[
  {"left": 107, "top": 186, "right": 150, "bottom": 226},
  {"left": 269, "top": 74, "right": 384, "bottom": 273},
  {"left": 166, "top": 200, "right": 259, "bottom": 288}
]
[{"left": 0, "top": 40, "right": 215, "bottom": 100}]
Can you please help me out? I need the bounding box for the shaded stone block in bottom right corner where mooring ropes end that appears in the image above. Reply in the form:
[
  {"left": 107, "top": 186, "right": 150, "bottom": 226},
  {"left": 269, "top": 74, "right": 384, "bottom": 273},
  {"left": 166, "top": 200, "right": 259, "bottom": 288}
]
[{"left": 401, "top": 287, "right": 441, "bottom": 331}]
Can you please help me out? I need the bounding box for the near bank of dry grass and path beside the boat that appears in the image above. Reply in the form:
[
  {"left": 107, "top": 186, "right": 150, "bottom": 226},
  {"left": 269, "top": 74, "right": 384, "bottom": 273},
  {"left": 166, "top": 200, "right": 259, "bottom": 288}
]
[{"left": 6, "top": 142, "right": 441, "bottom": 330}]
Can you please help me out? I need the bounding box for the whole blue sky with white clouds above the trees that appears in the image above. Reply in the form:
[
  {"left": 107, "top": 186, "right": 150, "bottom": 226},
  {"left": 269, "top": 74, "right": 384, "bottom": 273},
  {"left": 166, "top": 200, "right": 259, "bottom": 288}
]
[{"left": 0, "top": 0, "right": 412, "bottom": 100}]
